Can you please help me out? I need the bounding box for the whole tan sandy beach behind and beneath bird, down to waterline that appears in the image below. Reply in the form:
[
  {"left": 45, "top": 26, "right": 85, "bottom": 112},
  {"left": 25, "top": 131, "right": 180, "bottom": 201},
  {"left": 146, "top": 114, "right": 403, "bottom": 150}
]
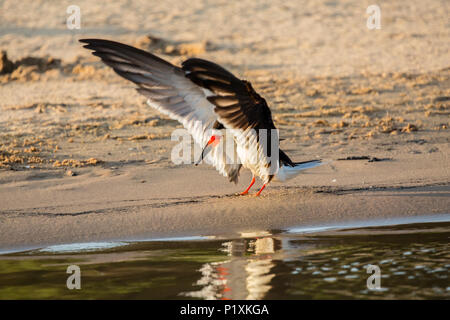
[{"left": 0, "top": 0, "right": 450, "bottom": 249}]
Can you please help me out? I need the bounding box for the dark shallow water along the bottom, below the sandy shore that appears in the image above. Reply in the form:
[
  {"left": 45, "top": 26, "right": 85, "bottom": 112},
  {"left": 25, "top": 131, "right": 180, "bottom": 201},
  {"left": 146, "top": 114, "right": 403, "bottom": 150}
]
[{"left": 0, "top": 215, "right": 450, "bottom": 299}]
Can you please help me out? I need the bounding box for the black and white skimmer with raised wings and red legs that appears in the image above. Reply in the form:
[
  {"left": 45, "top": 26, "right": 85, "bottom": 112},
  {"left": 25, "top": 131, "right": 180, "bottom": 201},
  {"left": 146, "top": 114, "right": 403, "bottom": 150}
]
[{"left": 80, "top": 39, "right": 322, "bottom": 195}]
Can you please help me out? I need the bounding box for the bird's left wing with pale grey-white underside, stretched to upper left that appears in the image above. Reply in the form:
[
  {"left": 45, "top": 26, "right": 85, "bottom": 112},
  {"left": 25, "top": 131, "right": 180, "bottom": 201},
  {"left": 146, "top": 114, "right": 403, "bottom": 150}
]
[{"left": 80, "top": 39, "right": 241, "bottom": 182}]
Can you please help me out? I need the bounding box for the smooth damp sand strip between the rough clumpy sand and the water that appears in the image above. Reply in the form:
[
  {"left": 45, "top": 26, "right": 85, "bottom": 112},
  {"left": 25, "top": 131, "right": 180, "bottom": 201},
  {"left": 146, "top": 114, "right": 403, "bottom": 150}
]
[{"left": 0, "top": 161, "right": 450, "bottom": 250}]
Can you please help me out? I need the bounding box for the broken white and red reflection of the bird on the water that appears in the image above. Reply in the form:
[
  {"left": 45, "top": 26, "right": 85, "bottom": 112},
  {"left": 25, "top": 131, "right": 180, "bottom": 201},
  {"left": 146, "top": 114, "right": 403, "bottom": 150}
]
[{"left": 183, "top": 237, "right": 277, "bottom": 300}]
